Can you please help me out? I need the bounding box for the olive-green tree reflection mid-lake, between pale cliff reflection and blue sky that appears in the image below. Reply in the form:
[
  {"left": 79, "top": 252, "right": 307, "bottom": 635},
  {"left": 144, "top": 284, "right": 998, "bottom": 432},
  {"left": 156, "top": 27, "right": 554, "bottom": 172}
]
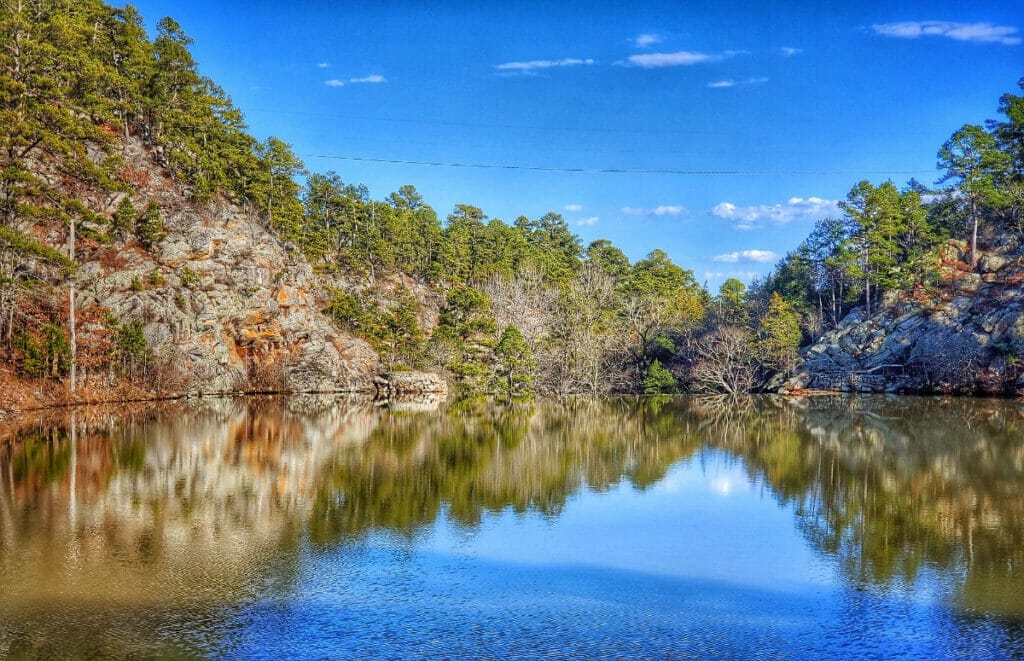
[{"left": 310, "top": 399, "right": 697, "bottom": 544}]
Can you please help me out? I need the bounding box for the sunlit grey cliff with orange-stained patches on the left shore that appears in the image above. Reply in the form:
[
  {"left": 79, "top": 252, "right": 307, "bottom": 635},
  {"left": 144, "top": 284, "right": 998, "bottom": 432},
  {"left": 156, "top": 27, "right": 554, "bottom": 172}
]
[{"left": 76, "top": 144, "right": 381, "bottom": 394}]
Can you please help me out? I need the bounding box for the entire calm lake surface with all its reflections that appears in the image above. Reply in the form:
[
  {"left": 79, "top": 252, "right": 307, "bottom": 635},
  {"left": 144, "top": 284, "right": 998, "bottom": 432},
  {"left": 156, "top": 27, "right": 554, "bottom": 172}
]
[{"left": 0, "top": 398, "right": 1024, "bottom": 659}]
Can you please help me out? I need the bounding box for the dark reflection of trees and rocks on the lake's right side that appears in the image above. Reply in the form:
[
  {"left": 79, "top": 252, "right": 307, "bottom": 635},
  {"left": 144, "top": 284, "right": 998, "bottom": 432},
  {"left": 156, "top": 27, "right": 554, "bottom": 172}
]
[{"left": 694, "top": 398, "right": 1024, "bottom": 616}]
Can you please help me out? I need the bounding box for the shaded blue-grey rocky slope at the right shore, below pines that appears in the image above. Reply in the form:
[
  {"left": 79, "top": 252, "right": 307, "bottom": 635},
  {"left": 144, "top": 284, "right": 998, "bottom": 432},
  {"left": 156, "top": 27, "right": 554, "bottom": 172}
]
[{"left": 774, "top": 241, "right": 1024, "bottom": 394}]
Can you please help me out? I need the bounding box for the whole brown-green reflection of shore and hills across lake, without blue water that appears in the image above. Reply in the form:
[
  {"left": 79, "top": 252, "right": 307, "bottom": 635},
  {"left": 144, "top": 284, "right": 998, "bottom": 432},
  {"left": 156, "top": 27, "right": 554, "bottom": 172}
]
[{"left": 0, "top": 398, "right": 1024, "bottom": 655}]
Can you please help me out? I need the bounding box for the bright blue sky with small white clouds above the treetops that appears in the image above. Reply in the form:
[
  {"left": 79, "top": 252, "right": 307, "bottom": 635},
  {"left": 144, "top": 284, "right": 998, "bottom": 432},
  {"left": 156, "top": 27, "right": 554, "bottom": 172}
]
[{"left": 117, "top": 0, "right": 1024, "bottom": 290}]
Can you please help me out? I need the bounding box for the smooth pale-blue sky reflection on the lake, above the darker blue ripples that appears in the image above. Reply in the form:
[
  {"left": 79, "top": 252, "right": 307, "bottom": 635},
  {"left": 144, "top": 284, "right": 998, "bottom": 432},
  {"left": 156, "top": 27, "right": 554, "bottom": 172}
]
[{"left": 424, "top": 452, "right": 834, "bottom": 591}]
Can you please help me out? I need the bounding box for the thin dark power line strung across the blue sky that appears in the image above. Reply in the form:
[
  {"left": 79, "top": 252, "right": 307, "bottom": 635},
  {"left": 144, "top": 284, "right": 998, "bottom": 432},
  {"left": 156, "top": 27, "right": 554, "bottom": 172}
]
[{"left": 300, "top": 153, "right": 935, "bottom": 176}]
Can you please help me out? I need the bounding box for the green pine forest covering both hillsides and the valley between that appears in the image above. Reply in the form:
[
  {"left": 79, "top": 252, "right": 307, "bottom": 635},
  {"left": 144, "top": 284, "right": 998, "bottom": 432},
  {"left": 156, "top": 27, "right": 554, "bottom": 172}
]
[{"left": 0, "top": 0, "right": 1024, "bottom": 400}]
